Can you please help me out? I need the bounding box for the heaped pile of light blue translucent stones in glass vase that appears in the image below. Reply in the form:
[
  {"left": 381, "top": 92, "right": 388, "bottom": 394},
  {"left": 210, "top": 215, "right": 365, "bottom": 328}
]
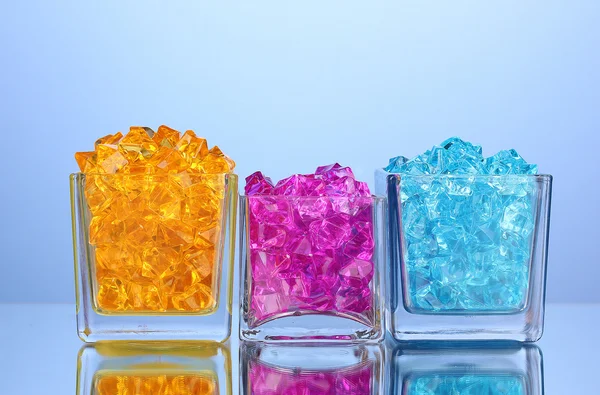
[{"left": 385, "top": 137, "right": 537, "bottom": 314}]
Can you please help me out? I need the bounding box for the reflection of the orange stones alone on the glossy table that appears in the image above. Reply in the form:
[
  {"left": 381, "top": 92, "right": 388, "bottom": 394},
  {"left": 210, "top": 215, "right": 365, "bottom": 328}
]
[{"left": 94, "top": 374, "right": 218, "bottom": 395}]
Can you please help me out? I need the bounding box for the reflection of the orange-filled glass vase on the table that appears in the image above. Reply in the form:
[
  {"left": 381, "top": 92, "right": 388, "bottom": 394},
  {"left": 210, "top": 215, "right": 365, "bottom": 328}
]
[{"left": 75, "top": 342, "right": 232, "bottom": 395}]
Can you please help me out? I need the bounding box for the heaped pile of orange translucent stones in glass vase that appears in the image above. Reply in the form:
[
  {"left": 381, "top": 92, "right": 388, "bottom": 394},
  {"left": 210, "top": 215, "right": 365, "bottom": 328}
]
[{"left": 75, "top": 126, "right": 235, "bottom": 313}]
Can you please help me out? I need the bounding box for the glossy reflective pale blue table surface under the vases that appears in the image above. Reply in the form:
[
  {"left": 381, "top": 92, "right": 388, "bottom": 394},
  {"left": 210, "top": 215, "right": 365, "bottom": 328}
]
[{"left": 0, "top": 304, "right": 600, "bottom": 395}]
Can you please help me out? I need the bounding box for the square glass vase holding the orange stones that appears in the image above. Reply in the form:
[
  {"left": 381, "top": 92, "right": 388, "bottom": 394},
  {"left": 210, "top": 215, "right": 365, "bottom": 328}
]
[{"left": 70, "top": 173, "right": 237, "bottom": 342}]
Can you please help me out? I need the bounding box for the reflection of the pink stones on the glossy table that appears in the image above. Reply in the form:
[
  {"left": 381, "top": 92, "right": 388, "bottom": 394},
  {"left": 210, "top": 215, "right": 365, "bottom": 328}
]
[{"left": 248, "top": 362, "right": 373, "bottom": 395}]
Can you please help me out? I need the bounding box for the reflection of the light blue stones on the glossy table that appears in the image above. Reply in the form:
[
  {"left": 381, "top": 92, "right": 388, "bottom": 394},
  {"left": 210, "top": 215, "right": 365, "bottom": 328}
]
[{"left": 406, "top": 374, "right": 526, "bottom": 395}]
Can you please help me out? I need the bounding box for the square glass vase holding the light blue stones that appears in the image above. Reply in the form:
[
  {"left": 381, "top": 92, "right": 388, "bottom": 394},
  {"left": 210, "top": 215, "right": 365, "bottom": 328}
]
[{"left": 375, "top": 169, "right": 552, "bottom": 342}]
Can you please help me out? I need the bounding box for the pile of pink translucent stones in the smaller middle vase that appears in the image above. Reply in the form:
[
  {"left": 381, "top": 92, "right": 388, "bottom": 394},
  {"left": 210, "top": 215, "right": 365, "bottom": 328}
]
[{"left": 245, "top": 163, "right": 374, "bottom": 326}]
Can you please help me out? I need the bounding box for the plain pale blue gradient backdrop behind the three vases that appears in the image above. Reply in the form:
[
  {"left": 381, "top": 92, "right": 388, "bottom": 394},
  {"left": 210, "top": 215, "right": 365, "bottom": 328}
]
[{"left": 0, "top": 0, "right": 600, "bottom": 302}]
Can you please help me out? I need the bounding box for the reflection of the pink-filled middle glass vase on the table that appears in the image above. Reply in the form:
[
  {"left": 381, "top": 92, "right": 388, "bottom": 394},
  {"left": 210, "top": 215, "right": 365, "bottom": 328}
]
[{"left": 239, "top": 342, "right": 385, "bottom": 395}]
